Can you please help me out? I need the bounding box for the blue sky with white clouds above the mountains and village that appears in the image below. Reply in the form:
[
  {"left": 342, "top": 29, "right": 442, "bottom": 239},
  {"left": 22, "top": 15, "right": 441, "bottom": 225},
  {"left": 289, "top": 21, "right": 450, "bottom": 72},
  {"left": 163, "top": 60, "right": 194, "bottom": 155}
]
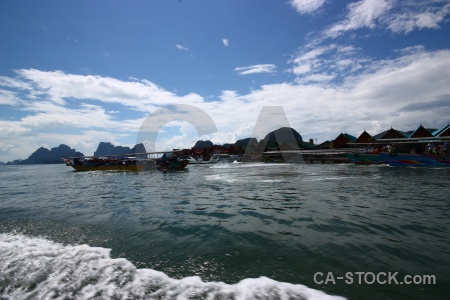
[{"left": 0, "top": 0, "right": 450, "bottom": 162}]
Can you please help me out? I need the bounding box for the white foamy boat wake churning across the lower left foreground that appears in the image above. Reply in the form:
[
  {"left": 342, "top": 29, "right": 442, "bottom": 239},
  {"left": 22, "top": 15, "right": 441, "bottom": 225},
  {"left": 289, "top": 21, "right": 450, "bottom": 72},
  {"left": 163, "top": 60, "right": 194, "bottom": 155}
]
[{"left": 0, "top": 233, "right": 344, "bottom": 299}]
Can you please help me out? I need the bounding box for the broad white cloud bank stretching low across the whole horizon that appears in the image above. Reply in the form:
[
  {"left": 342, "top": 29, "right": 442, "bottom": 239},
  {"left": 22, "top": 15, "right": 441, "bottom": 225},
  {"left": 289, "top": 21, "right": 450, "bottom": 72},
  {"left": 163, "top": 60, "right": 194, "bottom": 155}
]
[{"left": 0, "top": 45, "right": 450, "bottom": 161}]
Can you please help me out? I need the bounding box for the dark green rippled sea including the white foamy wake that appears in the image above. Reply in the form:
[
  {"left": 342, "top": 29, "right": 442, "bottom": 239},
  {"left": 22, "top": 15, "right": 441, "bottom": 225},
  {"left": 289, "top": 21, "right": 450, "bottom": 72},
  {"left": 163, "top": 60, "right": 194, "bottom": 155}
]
[{"left": 0, "top": 163, "right": 450, "bottom": 300}]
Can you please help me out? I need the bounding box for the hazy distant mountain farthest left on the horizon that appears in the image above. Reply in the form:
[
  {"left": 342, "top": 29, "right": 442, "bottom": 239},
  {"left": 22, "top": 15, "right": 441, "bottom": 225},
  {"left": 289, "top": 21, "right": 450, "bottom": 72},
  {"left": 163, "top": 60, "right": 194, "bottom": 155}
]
[{"left": 10, "top": 144, "right": 84, "bottom": 165}]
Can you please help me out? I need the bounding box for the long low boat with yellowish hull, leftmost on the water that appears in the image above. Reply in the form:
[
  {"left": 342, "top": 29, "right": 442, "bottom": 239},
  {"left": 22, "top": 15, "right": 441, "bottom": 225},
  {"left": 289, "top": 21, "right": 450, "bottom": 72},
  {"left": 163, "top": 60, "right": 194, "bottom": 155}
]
[{"left": 63, "top": 152, "right": 189, "bottom": 172}]
